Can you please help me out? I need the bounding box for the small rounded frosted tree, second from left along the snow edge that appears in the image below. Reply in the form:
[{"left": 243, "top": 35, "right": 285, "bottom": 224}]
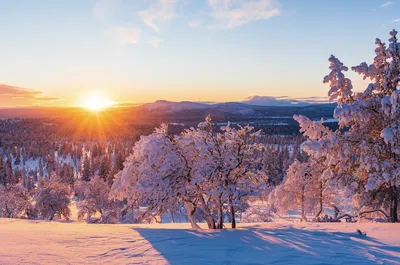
[{"left": 34, "top": 175, "right": 71, "bottom": 220}]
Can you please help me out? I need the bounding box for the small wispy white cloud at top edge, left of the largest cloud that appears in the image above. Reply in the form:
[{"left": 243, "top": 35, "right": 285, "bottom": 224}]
[{"left": 139, "top": 0, "right": 177, "bottom": 32}]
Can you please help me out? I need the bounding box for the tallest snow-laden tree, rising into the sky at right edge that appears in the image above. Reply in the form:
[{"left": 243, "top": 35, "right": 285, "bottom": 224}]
[{"left": 294, "top": 30, "right": 400, "bottom": 222}]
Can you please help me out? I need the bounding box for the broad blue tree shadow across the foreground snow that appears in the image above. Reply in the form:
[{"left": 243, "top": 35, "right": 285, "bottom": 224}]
[{"left": 130, "top": 227, "right": 400, "bottom": 265}]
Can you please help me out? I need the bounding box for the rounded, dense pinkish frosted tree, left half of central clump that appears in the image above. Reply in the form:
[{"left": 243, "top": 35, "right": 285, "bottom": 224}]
[{"left": 112, "top": 125, "right": 186, "bottom": 225}]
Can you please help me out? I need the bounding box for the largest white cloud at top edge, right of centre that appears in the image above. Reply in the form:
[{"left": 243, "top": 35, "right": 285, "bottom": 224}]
[{"left": 208, "top": 0, "right": 280, "bottom": 29}]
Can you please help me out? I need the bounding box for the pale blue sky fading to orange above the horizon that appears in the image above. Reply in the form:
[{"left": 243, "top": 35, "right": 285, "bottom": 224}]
[{"left": 0, "top": 0, "right": 400, "bottom": 107}]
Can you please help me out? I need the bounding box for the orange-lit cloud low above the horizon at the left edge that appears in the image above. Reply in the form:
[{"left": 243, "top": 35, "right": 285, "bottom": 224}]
[{"left": 0, "top": 84, "right": 61, "bottom": 107}]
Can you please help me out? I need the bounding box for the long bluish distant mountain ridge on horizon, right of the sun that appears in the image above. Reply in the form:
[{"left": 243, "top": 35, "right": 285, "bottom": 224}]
[{"left": 131, "top": 97, "right": 335, "bottom": 122}]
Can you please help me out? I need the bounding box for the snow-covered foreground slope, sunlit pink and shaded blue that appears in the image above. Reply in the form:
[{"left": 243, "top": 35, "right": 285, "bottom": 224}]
[{"left": 0, "top": 219, "right": 400, "bottom": 265}]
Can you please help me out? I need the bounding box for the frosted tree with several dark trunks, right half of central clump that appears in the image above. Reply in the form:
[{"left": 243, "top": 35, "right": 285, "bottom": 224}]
[{"left": 178, "top": 117, "right": 267, "bottom": 228}]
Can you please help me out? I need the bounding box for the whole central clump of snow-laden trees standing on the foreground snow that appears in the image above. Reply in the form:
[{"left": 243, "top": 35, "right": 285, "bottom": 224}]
[{"left": 112, "top": 117, "right": 266, "bottom": 228}]
